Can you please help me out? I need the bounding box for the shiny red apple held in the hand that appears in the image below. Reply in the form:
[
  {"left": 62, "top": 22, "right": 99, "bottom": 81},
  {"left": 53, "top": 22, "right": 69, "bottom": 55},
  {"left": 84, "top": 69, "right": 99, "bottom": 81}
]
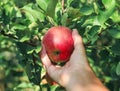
[{"left": 43, "top": 26, "right": 74, "bottom": 63}]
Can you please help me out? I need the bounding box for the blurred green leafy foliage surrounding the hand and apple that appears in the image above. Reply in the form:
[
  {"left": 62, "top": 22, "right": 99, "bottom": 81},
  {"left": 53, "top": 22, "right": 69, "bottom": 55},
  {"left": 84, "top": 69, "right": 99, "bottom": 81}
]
[{"left": 0, "top": 0, "right": 120, "bottom": 91}]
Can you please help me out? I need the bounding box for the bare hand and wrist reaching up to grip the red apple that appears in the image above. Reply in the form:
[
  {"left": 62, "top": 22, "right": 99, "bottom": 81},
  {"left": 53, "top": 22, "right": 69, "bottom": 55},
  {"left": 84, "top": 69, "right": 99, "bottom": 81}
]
[{"left": 40, "top": 30, "right": 109, "bottom": 91}]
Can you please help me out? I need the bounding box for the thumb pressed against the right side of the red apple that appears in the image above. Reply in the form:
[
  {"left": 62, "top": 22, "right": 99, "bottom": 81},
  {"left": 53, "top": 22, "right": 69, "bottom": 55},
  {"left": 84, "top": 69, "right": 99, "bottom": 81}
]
[{"left": 70, "top": 29, "right": 87, "bottom": 63}]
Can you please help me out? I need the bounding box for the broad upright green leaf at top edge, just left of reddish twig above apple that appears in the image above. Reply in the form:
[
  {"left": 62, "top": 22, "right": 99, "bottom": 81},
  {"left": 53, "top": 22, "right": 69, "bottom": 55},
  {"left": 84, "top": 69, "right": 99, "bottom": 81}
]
[{"left": 46, "top": 0, "right": 58, "bottom": 19}]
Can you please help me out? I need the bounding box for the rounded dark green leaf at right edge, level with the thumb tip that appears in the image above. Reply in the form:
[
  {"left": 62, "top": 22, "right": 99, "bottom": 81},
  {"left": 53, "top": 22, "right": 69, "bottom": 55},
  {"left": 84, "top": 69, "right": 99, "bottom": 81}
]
[{"left": 108, "top": 28, "right": 120, "bottom": 39}]
